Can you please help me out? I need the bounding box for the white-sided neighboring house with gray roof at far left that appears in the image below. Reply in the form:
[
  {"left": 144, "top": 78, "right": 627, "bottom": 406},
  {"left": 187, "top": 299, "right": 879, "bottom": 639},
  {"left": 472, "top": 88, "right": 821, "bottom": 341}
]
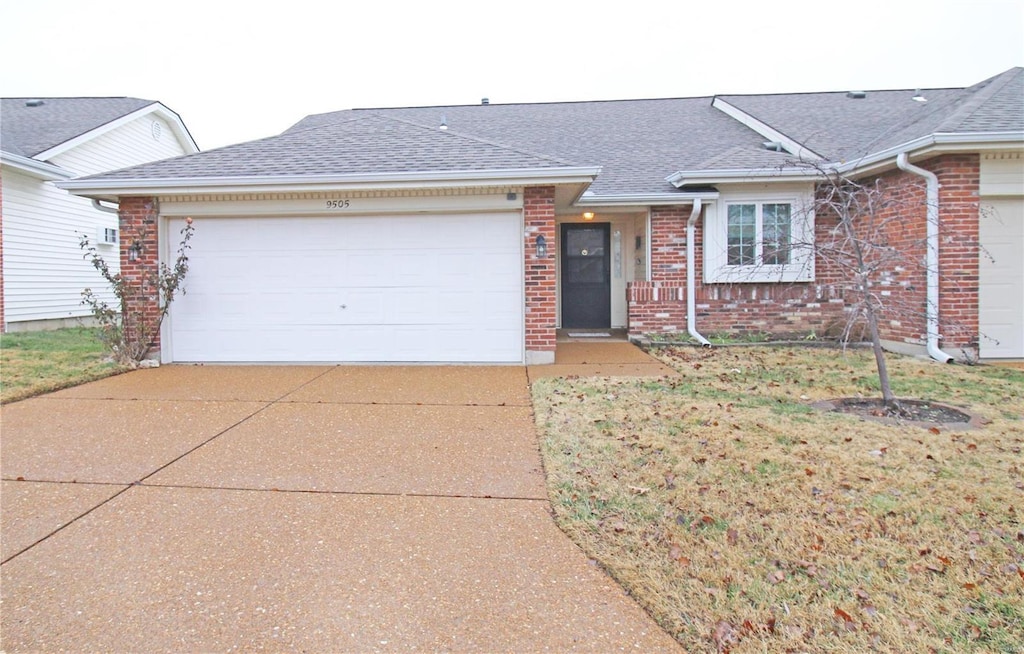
[{"left": 0, "top": 97, "right": 199, "bottom": 332}]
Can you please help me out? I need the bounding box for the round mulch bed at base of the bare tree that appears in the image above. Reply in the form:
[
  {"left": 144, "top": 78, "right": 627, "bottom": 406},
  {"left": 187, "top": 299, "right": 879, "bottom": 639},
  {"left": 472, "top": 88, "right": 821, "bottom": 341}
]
[{"left": 811, "top": 397, "right": 988, "bottom": 431}]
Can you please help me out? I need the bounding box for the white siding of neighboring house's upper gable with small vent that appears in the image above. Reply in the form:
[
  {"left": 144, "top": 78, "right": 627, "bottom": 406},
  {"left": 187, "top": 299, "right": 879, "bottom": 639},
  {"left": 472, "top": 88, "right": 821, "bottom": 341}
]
[{"left": 52, "top": 114, "right": 185, "bottom": 176}]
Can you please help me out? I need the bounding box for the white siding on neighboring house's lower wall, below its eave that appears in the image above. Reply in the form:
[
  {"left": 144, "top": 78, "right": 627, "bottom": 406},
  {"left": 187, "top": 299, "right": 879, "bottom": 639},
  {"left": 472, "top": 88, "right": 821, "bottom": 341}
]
[{"left": 3, "top": 168, "right": 119, "bottom": 322}]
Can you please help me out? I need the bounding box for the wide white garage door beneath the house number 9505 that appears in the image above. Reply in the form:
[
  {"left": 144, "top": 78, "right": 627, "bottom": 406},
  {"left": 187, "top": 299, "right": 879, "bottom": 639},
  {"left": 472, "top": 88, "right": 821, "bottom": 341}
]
[{"left": 164, "top": 213, "right": 523, "bottom": 362}]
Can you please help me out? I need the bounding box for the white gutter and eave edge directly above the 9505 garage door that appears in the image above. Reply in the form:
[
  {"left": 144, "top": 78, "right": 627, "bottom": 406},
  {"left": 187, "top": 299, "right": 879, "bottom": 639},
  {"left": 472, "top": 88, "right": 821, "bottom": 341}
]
[{"left": 57, "top": 167, "right": 601, "bottom": 200}]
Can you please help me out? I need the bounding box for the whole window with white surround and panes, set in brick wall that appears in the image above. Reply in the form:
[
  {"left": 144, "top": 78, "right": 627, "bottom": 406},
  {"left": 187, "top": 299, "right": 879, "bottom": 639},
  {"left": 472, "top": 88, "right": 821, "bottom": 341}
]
[{"left": 705, "top": 190, "right": 814, "bottom": 282}]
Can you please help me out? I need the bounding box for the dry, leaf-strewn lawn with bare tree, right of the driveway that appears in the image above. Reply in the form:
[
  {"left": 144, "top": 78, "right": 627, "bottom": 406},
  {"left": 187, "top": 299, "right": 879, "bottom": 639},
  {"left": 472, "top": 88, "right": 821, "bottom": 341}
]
[{"left": 532, "top": 347, "right": 1024, "bottom": 653}]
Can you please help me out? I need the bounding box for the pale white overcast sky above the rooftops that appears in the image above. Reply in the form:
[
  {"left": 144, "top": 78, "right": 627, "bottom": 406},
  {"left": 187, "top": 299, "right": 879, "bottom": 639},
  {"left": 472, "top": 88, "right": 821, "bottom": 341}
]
[{"left": 0, "top": 0, "right": 1024, "bottom": 149}]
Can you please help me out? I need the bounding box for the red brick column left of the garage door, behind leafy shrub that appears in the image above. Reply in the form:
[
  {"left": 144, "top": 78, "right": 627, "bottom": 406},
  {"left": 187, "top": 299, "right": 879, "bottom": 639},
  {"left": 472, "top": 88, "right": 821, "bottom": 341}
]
[{"left": 118, "top": 198, "right": 160, "bottom": 356}]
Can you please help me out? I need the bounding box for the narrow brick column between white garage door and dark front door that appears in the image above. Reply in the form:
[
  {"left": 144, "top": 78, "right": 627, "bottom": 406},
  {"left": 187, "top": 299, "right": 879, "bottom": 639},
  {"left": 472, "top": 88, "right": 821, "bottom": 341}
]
[{"left": 522, "top": 186, "right": 557, "bottom": 364}]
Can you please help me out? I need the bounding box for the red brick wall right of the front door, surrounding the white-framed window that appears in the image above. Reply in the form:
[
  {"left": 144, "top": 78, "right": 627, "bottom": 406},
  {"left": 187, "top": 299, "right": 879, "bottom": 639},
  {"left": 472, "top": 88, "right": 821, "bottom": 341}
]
[{"left": 627, "top": 155, "right": 980, "bottom": 348}]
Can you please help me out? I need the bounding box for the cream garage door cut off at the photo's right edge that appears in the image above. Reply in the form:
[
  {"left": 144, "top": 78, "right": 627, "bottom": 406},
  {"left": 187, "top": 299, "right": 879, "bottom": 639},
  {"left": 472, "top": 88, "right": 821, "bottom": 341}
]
[{"left": 978, "top": 199, "right": 1024, "bottom": 358}]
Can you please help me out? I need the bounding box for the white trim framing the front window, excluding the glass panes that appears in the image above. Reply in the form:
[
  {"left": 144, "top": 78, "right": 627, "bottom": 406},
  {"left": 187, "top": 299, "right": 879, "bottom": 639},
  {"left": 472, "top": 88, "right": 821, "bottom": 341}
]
[{"left": 703, "top": 191, "right": 814, "bottom": 284}]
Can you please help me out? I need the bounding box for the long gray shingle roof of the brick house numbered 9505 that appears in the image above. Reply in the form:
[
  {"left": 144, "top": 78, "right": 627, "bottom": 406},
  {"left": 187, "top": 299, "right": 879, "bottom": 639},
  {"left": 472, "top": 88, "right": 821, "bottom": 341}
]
[{"left": 68, "top": 69, "right": 1024, "bottom": 195}]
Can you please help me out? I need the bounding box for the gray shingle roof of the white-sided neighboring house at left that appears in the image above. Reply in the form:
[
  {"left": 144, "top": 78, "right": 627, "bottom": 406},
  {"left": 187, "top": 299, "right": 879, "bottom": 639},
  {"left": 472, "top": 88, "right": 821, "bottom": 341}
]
[{"left": 0, "top": 97, "right": 154, "bottom": 157}]
